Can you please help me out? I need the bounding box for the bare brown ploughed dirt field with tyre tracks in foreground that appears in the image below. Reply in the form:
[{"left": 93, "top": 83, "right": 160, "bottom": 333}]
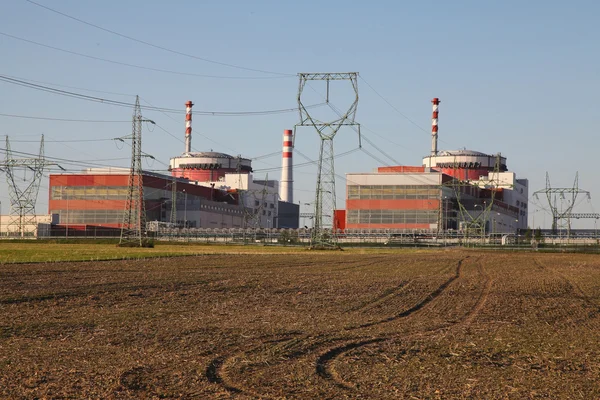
[{"left": 0, "top": 251, "right": 600, "bottom": 399}]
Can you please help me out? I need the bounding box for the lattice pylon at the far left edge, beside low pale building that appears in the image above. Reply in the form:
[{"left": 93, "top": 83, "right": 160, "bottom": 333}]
[{"left": 0, "top": 135, "right": 57, "bottom": 237}]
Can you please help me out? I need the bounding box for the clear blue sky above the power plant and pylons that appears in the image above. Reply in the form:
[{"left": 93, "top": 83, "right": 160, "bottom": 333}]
[{"left": 0, "top": 0, "right": 600, "bottom": 228}]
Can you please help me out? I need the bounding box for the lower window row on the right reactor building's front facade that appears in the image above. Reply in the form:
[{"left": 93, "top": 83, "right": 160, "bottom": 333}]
[{"left": 347, "top": 210, "right": 440, "bottom": 224}]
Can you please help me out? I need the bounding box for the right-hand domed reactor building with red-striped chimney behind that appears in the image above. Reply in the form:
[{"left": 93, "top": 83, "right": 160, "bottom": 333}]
[{"left": 336, "top": 98, "right": 529, "bottom": 234}]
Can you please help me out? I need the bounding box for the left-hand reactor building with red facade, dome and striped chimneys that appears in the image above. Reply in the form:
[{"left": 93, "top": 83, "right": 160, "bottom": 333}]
[{"left": 48, "top": 101, "right": 300, "bottom": 234}]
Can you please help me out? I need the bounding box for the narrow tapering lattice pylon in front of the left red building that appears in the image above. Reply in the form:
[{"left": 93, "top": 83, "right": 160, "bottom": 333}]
[{"left": 119, "top": 96, "right": 148, "bottom": 247}]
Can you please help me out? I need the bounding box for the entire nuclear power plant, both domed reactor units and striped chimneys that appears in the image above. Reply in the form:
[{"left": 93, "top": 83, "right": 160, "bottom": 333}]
[{"left": 8, "top": 92, "right": 599, "bottom": 242}]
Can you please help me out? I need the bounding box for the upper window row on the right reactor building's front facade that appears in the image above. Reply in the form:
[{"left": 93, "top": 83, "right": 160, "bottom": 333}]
[{"left": 348, "top": 185, "right": 440, "bottom": 200}]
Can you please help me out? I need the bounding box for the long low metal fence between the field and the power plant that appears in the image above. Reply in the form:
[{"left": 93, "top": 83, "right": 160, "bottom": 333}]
[{"left": 0, "top": 225, "right": 600, "bottom": 251}]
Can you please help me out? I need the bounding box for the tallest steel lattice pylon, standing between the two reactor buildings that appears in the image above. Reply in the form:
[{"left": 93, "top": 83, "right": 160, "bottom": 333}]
[{"left": 294, "top": 72, "right": 360, "bottom": 248}]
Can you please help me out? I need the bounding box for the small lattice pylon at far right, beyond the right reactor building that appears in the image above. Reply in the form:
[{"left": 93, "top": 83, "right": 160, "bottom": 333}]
[{"left": 533, "top": 172, "right": 591, "bottom": 236}]
